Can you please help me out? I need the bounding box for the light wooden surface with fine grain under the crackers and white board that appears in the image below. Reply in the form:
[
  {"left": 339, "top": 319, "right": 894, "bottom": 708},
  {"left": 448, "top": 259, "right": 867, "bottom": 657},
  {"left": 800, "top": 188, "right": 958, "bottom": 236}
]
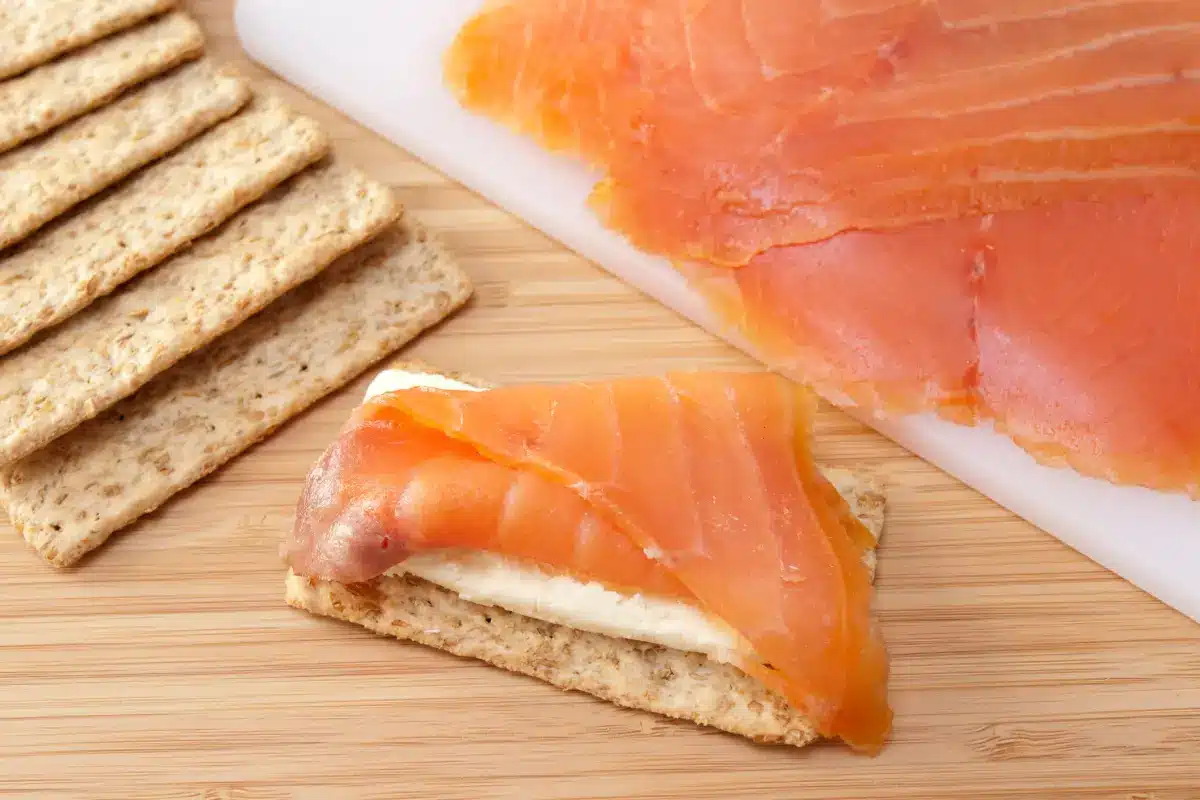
[{"left": 0, "top": 0, "right": 1200, "bottom": 800}]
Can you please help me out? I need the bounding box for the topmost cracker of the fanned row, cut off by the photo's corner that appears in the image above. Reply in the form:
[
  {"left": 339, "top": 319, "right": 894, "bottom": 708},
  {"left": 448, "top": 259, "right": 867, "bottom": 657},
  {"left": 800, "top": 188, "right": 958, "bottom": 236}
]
[{"left": 0, "top": 0, "right": 175, "bottom": 79}]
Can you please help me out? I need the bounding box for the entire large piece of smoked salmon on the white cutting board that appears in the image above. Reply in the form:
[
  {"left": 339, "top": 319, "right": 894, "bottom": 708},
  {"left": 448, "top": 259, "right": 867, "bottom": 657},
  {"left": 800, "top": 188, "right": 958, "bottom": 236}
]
[{"left": 445, "top": 0, "right": 1200, "bottom": 497}]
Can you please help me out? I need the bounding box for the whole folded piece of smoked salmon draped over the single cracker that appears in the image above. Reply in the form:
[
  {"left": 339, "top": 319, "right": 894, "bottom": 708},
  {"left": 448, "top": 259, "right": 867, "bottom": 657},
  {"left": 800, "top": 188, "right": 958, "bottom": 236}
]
[{"left": 286, "top": 373, "right": 892, "bottom": 752}]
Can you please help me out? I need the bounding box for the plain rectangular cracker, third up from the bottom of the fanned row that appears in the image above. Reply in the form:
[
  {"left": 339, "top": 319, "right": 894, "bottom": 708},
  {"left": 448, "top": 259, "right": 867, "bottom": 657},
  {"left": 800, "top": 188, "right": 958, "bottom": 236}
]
[{"left": 0, "top": 97, "right": 329, "bottom": 355}]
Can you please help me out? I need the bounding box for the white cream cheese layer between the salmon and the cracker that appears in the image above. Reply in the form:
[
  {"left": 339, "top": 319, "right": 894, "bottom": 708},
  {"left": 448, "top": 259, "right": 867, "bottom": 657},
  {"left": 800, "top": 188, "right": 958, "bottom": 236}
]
[{"left": 366, "top": 369, "right": 738, "bottom": 661}]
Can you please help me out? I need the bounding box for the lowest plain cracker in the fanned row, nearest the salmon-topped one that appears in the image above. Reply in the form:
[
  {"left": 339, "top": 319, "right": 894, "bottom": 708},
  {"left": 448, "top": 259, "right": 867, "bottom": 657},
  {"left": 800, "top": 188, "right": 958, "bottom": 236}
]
[{"left": 0, "top": 221, "right": 470, "bottom": 566}]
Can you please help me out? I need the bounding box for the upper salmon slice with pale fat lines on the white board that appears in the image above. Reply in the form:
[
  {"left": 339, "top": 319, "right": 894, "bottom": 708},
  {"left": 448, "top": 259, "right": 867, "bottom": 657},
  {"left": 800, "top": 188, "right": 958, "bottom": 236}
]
[{"left": 446, "top": 0, "right": 1200, "bottom": 266}]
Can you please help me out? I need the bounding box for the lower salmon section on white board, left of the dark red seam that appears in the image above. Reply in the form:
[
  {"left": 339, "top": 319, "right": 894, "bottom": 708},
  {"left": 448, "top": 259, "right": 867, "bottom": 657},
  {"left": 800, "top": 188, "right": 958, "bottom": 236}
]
[{"left": 679, "top": 221, "right": 982, "bottom": 423}]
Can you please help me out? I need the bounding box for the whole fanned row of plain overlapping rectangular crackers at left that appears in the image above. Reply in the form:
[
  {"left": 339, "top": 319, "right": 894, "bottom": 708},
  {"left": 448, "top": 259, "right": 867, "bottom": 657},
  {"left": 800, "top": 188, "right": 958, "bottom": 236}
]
[{"left": 0, "top": 0, "right": 470, "bottom": 566}]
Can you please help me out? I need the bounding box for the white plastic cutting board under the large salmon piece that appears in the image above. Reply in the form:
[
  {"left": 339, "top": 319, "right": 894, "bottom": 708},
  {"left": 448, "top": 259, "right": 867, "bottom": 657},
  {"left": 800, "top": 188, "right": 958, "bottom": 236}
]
[{"left": 236, "top": 0, "right": 1200, "bottom": 621}]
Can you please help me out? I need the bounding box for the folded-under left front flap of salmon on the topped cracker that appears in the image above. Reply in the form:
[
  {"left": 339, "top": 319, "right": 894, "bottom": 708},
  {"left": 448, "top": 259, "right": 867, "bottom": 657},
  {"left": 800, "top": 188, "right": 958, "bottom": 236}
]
[{"left": 286, "top": 419, "right": 691, "bottom": 599}]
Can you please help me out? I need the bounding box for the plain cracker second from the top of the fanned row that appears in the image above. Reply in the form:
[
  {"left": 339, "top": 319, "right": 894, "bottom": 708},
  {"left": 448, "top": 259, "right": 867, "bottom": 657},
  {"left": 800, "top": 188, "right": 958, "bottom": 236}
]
[{"left": 0, "top": 12, "right": 204, "bottom": 152}]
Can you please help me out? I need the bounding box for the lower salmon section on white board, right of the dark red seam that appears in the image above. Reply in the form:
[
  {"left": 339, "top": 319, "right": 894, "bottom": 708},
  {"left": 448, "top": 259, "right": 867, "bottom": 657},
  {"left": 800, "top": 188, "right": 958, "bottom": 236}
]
[{"left": 977, "top": 192, "right": 1200, "bottom": 497}]
